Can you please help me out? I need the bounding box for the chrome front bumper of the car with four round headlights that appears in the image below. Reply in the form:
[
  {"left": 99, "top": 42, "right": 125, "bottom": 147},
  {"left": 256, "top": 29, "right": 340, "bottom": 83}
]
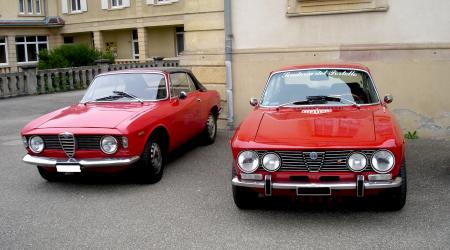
[{"left": 231, "top": 176, "right": 402, "bottom": 190}]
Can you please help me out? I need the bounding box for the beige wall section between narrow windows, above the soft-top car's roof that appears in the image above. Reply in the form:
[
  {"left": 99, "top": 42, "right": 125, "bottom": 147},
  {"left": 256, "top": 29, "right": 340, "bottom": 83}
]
[{"left": 147, "top": 27, "right": 176, "bottom": 58}]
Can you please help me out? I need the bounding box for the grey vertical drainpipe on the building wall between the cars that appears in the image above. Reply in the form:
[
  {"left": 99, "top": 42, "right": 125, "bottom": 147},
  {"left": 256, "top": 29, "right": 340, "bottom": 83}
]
[{"left": 224, "top": 0, "right": 234, "bottom": 129}]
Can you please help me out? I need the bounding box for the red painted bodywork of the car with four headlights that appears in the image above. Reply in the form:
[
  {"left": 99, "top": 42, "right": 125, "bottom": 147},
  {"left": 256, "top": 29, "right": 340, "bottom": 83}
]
[{"left": 230, "top": 64, "right": 405, "bottom": 195}]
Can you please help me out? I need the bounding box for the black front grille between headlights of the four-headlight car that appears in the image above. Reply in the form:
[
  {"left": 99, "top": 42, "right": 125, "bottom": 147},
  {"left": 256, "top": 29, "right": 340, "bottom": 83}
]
[{"left": 257, "top": 150, "right": 376, "bottom": 172}]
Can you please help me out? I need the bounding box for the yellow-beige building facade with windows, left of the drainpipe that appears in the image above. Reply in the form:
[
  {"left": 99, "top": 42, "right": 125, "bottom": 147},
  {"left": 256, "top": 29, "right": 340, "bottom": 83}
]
[{"left": 0, "top": 0, "right": 226, "bottom": 123}]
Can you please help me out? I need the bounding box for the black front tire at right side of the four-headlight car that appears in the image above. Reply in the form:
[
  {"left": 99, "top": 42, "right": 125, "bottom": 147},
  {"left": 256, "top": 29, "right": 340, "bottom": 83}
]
[{"left": 380, "top": 162, "right": 407, "bottom": 211}]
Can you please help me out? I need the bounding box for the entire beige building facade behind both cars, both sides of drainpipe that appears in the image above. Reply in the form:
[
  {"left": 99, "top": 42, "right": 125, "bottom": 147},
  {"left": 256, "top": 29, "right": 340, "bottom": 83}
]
[{"left": 0, "top": 0, "right": 450, "bottom": 137}]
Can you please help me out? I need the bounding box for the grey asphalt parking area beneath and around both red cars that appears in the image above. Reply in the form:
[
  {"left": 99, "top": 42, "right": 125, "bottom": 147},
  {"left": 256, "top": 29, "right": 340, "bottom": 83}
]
[{"left": 0, "top": 92, "right": 450, "bottom": 249}]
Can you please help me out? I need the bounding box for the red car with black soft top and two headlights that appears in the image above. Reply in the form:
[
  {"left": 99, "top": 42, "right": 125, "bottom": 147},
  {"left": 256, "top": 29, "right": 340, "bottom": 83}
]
[{"left": 21, "top": 68, "right": 221, "bottom": 183}]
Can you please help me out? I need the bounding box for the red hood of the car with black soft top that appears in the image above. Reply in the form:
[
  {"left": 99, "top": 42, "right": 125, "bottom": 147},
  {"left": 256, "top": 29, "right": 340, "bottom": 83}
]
[{"left": 39, "top": 103, "right": 150, "bottom": 128}]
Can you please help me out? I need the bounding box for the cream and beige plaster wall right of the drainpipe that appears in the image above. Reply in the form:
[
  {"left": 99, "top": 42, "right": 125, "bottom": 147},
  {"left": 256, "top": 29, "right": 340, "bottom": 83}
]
[{"left": 232, "top": 0, "right": 450, "bottom": 138}]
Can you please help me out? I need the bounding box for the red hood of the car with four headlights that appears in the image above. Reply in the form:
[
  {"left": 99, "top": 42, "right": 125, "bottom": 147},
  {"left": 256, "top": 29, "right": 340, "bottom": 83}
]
[{"left": 255, "top": 108, "right": 376, "bottom": 144}]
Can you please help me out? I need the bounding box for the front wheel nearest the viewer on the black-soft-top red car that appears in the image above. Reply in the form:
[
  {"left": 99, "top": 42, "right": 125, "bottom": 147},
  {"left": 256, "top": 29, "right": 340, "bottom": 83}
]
[{"left": 137, "top": 137, "right": 166, "bottom": 184}]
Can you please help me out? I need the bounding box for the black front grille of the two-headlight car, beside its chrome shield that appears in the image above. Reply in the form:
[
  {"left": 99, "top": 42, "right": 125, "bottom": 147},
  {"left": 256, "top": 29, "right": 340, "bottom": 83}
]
[{"left": 41, "top": 135, "right": 102, "bottom": 150}]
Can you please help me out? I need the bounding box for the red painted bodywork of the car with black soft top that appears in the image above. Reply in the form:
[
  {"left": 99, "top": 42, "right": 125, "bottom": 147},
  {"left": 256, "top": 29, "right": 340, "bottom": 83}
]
[{"left": 21, "top": 69, "right": 221, "bottom": 171}]
